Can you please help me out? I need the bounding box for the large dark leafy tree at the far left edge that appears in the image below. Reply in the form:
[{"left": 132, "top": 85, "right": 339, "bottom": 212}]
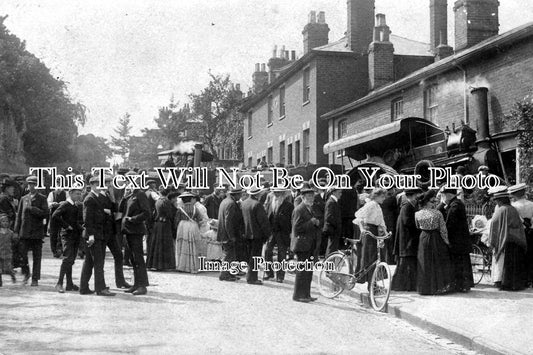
[{"left": 0, "top": 17, "right": 86, "bottom": 166}]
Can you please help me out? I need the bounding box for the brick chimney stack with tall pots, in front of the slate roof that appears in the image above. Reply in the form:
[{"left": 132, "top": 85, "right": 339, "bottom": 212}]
[{"left": 368, "top": 14, "right": 394, "bottom": 90}]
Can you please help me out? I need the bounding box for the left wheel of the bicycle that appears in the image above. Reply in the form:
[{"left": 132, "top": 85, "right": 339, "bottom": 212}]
[{"left": 318, "top": 252, "right": 351, "bottom": 298}]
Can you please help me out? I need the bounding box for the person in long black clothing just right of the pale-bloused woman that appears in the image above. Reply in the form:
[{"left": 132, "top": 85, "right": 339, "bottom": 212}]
[{"left": 437, "top": 189, "right": 474, "bottom": 292}]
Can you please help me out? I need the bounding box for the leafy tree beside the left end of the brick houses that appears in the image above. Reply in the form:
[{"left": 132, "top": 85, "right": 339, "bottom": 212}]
[{"left": 190, "top": 73, "right": 243, "bottom": 159}]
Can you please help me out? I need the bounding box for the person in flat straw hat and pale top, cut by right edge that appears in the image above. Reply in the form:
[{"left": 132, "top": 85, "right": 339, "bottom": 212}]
[{"left": 509, "top": 183, "right": 533, "bottom": 287}]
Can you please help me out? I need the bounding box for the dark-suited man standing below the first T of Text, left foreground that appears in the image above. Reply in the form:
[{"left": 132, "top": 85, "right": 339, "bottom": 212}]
[{"left": 80, "top": 176, "right": 115, "bottom": 296}]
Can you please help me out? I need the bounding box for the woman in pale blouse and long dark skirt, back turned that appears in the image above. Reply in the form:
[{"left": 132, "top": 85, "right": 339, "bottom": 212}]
[{"left": 415, "top": 190, "right": 455, "bottom": 295}]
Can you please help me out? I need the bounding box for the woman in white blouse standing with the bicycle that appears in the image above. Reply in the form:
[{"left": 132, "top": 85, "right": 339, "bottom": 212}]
[{"left": 354, "top": 189, "right": 387, "bottom": 287}]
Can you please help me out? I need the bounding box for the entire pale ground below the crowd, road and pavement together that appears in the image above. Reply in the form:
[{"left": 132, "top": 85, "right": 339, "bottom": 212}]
[{"left": 0, "top": 239, "right": 533, "bottom": 354}]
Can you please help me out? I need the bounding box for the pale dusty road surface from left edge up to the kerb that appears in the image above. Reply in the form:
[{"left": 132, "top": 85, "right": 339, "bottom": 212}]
[{"left": 0, "top": 244, "right": 476, "bottom": 355}]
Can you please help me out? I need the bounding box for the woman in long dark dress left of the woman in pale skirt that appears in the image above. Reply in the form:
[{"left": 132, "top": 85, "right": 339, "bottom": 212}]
[{"left": 146, "top": 189, "right": 178, "bottom": 270}]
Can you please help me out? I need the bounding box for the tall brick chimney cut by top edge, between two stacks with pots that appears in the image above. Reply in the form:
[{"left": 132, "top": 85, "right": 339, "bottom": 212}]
[{"left": 346, "top": 0, "right": 375, "bottom": 55}]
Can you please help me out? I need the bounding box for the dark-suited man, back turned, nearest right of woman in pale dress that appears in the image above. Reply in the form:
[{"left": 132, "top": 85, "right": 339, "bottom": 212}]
[{"left": 217, "top": 188, "right": 243, "bottom": 281}]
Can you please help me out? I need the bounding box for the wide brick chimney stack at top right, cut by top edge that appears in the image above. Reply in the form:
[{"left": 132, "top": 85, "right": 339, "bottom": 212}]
[{"left": 453, "top": 0, "right": 500, "bottom": 50}]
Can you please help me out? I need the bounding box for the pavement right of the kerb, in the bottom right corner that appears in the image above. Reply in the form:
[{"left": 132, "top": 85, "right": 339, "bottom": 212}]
[{"left": 315, "top": 266, "right": 533, "bottom": 354}]
